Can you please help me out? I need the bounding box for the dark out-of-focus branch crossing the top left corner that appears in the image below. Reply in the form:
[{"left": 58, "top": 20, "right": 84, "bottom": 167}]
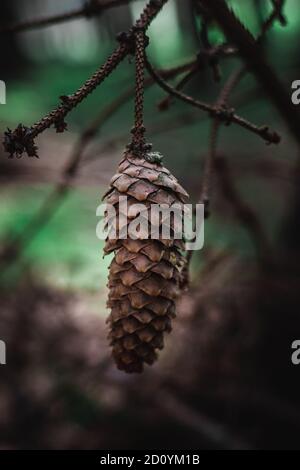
[{"left": 0, "top": 0, "right": 132, "bottom": 34}]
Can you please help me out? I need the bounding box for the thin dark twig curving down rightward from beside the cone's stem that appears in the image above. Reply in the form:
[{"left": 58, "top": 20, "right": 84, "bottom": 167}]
[{"left": 146, "top": 55, "right": 280, "bottom": 144}]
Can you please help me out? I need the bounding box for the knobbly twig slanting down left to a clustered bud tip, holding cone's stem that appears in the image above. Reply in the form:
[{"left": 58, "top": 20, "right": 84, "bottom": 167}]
[{"left": 4, "top": 0, "right": 168, "bottom": 157}]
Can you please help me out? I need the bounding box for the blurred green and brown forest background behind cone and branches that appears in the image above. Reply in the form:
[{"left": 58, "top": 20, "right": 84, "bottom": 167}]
[{"left": 0, "top": 0, "right": 300, "bottom": 449}]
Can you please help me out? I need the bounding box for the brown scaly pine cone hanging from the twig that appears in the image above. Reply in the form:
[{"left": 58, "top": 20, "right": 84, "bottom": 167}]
[{"left": 104, "top": 151, "right": 188, "bottom": 372}]
